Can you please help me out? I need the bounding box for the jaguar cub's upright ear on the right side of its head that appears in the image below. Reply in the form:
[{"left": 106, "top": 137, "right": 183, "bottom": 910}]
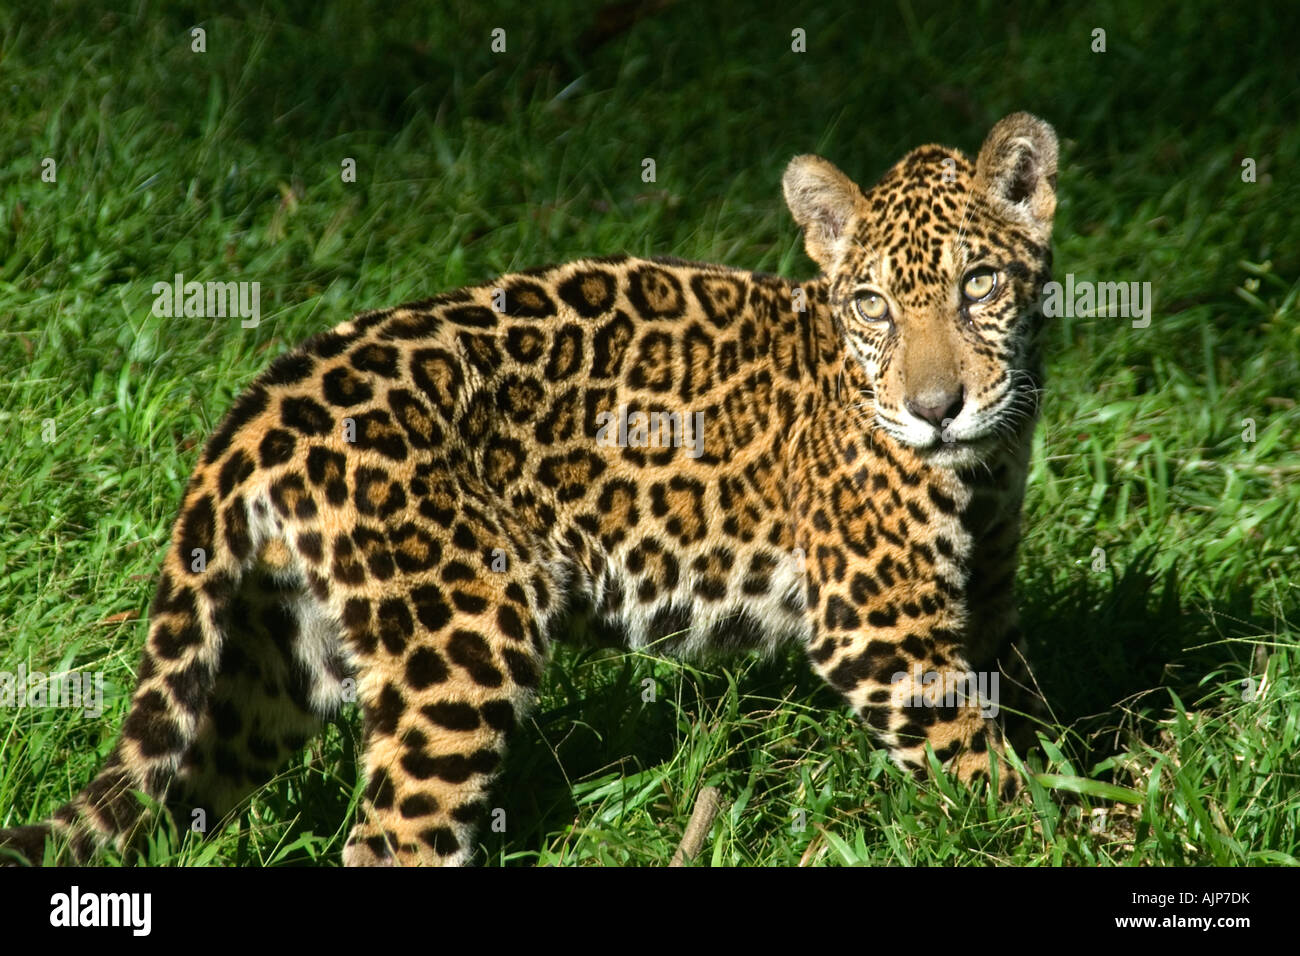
[{"left": 975, "top": 113, "right": 1058, "bottom": 239}]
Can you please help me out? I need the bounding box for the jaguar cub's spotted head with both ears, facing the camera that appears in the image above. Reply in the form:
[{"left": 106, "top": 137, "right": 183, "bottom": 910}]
[{"left": 783, "top": 113, "right": 1057, "bottom": 467}]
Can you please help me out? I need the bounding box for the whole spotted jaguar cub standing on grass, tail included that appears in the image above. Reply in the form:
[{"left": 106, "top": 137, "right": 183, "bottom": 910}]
[{"left": 0, "top": 113, "right": 1057, "bottom": 865}]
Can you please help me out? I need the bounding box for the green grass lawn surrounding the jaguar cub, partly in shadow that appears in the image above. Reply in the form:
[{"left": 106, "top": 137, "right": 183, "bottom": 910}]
[{"left": 0, "top": 0, "right": 1300, "bottom": 865}]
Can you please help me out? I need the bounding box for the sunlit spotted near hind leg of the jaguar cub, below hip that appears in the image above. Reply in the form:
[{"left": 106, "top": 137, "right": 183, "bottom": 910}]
[{"left": 343, "top": 551, "right": 555, "bottom": 866}]
